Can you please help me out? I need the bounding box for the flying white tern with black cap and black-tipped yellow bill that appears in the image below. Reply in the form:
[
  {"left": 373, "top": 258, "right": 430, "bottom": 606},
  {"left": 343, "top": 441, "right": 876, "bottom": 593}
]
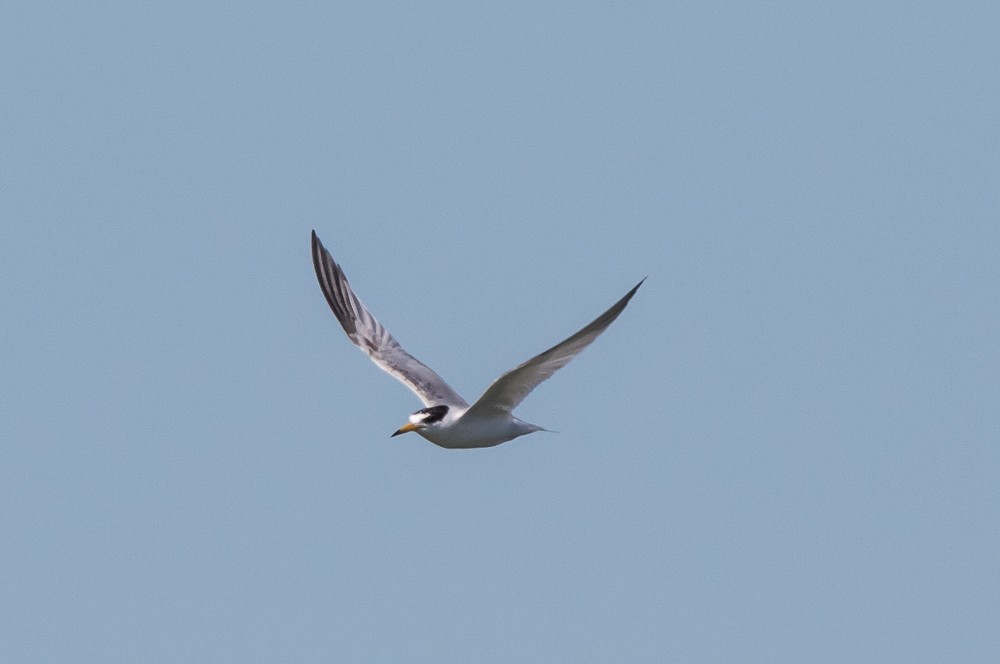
[{"left": 312, "top": 231, "right": 645, "bottom": 449}]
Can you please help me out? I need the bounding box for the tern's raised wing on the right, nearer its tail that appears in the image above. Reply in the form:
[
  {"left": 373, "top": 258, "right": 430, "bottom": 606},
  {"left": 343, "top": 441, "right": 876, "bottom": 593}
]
[{"left": 467, "top": 279, "right": 645, "bottom": 417}]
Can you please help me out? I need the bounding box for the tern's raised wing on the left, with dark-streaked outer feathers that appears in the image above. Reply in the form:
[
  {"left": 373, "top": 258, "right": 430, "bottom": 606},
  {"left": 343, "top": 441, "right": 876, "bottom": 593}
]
[{"left": 312, "top": 231, "right": 468, "bottom": 407}]
